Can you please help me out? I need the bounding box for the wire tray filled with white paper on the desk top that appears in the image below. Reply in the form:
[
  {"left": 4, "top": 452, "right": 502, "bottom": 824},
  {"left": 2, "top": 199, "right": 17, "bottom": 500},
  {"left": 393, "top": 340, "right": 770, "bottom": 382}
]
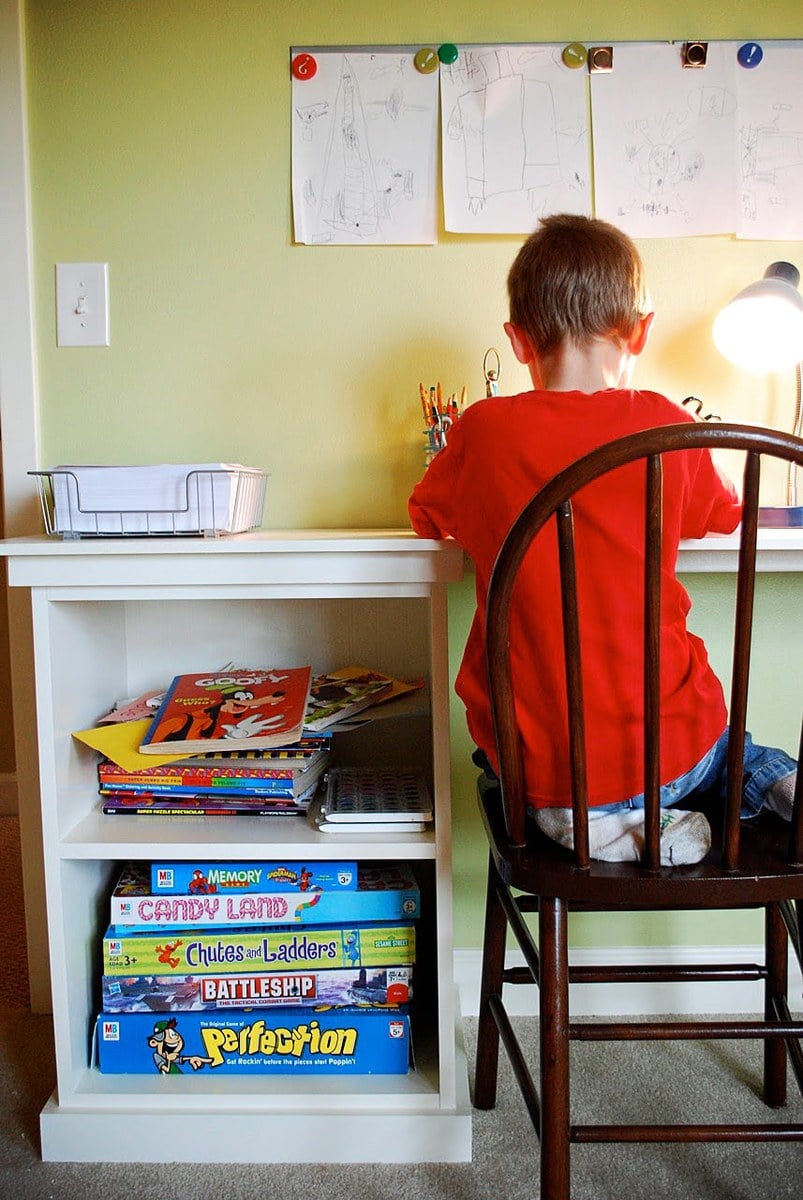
[{"left": 48, "top": 462, "right": 264, "bottom": 534}]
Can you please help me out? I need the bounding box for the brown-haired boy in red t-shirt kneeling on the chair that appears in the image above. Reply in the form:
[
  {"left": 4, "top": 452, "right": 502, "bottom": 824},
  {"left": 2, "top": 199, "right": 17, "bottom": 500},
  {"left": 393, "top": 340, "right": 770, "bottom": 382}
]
[{"left": 409, "top": 215, "right": 796, "bottom": 864}]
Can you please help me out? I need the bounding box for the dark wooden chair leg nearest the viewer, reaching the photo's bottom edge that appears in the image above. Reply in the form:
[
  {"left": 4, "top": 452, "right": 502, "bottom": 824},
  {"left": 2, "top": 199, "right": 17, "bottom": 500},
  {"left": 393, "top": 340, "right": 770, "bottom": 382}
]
[{"left": 539, "top": 899, "right": 570, "bottom": 1200}]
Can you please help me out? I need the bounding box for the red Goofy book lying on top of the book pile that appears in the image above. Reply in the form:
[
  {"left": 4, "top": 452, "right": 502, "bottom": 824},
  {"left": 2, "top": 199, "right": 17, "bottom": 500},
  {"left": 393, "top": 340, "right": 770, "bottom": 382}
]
[{"left": 139, "top": 666, "right": 312, "bottom": 754}]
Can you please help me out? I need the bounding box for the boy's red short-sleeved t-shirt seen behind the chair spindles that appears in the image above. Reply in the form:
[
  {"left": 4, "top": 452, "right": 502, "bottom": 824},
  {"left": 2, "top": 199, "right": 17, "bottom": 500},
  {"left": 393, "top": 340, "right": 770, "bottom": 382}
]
[{"left": 409, "top": 389, "right": 741, "bottom": 808}]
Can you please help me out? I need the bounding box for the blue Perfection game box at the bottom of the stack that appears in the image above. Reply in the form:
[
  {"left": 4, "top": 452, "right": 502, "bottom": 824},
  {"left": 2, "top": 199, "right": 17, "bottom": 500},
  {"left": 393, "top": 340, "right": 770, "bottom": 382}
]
[{"left": 92, "top": 1007, "right": 411, "bottom": 1079}]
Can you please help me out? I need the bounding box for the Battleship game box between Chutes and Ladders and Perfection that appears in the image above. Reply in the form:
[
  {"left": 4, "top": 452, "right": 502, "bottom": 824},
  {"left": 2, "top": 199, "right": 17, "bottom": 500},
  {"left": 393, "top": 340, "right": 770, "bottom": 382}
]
[{"left": 101, "top": 966, "right": 413, "bottom": 1014}]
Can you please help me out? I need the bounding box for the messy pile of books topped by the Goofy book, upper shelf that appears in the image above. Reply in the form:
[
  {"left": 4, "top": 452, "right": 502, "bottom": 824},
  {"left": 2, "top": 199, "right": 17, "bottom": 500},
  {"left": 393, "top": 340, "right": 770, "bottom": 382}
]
[{"left": 85, "top": 666, "right": 423, "bottom": 816}]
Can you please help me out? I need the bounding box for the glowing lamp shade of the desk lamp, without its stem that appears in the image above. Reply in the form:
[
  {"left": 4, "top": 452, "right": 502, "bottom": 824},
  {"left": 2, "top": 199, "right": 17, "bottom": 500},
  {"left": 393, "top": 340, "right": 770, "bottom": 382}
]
[{"left": 713, "top": 263, "right": 803, "bottom": 371}]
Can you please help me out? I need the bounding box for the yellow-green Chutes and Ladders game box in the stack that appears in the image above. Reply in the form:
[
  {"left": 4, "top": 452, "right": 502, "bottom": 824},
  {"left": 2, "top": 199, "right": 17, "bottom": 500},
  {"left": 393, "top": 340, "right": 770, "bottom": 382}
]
[{"left": 102, "top": 922, "right": 415, "bottom": 976}]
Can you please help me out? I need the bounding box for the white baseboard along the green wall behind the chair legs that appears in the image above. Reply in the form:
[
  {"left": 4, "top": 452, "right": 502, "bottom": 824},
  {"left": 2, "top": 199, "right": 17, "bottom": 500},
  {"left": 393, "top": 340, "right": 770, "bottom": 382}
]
[{"left": 455, "top": 946, "right": 803, "bottom": 1016}]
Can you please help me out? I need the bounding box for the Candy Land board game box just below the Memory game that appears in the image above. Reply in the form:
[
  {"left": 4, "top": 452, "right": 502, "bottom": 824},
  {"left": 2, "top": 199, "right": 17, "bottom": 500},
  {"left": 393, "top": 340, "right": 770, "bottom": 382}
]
[{"left": 110, "top": 863, "right": 420, "bottom": 931}]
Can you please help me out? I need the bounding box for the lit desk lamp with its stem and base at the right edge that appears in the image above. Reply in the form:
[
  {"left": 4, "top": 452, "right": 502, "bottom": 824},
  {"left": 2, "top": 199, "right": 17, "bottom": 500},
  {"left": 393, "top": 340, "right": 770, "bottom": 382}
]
[{"left": 713, "top": 263, "right": 803, "bottom": 526}]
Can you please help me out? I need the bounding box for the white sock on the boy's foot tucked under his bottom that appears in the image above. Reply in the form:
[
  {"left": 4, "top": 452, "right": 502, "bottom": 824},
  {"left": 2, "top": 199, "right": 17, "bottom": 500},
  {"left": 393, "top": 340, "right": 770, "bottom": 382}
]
[{"left": 535, "top": 809, "right": 711, "bottom": 866}]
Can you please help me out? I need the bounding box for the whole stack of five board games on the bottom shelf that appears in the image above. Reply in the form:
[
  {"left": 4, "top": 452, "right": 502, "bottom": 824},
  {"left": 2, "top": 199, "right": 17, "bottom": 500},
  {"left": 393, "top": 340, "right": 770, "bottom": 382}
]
[{"left": 95, "top": 862, "right": 412, "bottom": 1074}]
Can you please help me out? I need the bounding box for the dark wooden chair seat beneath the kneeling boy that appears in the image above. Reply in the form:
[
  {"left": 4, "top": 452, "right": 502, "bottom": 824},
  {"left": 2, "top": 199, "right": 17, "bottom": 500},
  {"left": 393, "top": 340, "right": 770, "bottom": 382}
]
[{"left": 480, "top": 786, "right": 803, "bottom": 910}]
